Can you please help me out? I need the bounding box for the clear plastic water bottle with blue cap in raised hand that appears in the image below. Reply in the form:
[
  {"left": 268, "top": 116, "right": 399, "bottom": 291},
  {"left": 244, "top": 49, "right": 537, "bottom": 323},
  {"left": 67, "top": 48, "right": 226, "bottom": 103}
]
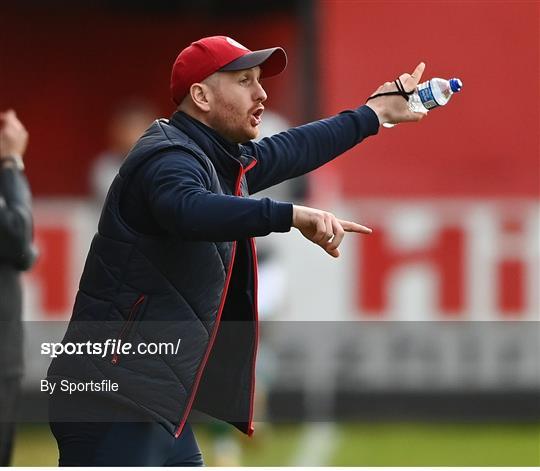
[{"left": 383, "top": 77, "right": 463, "bottom": 128}]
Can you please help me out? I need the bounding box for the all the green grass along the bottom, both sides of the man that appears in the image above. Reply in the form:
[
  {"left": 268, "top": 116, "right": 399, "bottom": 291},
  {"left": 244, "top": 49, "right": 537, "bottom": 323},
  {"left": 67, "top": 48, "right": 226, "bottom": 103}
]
[{"left": 13, "top": 423, "right": 540, "bottom": 467}]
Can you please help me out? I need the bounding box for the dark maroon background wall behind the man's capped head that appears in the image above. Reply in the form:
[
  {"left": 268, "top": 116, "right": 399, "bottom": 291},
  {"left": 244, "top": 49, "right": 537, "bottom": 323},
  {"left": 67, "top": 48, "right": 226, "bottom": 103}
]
[{"left": 0, "top": 1, "right": 302, "bottom": 196}]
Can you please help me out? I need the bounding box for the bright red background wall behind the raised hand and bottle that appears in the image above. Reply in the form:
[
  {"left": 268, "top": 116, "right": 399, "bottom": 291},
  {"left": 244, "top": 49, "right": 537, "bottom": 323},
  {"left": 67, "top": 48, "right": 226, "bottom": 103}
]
[{"left": 319, "top": 0, "right": 540, "bottom": 198}]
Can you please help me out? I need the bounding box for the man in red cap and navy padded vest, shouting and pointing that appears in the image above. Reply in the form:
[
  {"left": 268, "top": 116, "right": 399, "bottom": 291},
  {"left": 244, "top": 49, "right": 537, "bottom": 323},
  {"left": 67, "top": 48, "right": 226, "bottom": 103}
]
[{"left": 47, "top": 36, "right": 424, "bottom": 466}]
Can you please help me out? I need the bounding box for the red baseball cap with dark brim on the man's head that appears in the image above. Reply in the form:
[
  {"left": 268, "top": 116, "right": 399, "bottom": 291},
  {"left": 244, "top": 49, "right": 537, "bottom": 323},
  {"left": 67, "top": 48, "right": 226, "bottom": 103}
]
[{"left": 171, "top": 36, "right": 287, "bottom": 105}]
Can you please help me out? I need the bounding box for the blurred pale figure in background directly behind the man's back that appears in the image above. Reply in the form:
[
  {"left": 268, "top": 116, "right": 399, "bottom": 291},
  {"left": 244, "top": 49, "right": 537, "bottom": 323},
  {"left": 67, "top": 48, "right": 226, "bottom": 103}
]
[{"left": 90, "top": 98, "right": 156, "bottom": 205}]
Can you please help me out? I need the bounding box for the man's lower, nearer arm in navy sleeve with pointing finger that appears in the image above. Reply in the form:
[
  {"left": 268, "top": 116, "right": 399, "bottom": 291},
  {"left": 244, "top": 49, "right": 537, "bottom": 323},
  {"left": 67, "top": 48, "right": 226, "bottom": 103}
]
[{"left": 142, "top": 153, "right": 371, "bottom": 257}]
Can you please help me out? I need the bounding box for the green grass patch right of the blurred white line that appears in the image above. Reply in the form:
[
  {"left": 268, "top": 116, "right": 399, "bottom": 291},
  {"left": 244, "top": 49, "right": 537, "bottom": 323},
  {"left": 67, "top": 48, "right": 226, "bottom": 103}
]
[{"left": 329, "top": 423, "right": 540, "bottom": 467}]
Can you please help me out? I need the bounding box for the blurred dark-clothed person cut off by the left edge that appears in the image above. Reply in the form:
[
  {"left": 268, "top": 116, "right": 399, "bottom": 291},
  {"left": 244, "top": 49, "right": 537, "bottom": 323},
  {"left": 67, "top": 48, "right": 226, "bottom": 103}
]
[{"left": 0, "top": 110, "right": 36, "bottom": 466}]
